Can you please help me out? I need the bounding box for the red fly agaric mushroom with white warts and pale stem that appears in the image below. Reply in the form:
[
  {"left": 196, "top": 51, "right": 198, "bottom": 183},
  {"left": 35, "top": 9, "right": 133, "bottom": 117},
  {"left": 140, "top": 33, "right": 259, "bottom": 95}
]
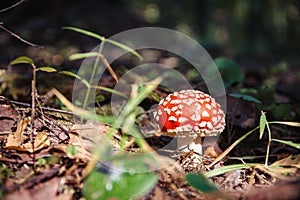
[{"left": 154, "top": 90, "right": 225, "bottom": 154}]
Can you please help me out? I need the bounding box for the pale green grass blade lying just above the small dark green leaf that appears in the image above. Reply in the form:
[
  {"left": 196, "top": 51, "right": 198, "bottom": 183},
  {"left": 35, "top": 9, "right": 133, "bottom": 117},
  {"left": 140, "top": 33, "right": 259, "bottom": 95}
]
[{"left": 204, "top": 163, "right": 259, "bottom": 178}]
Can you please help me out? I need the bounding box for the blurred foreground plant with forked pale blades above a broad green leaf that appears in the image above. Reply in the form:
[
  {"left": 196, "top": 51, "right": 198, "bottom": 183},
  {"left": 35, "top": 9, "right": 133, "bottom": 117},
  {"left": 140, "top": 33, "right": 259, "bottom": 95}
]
[{"left": 53, "top": 77, "right": 163, "bottom": 199}]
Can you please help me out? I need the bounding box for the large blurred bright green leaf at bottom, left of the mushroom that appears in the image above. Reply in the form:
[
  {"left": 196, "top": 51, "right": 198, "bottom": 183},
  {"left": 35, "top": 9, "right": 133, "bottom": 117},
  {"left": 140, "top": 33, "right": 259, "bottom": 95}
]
[{"left": 83, "top": 154, "right": 158, "bottom": 200}]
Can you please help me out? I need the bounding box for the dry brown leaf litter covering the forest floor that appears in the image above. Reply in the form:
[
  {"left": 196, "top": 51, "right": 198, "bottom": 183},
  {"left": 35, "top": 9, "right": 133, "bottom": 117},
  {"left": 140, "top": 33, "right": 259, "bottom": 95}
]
[{"left": 0, "top": 90, "right": 300, "bottom": 199}]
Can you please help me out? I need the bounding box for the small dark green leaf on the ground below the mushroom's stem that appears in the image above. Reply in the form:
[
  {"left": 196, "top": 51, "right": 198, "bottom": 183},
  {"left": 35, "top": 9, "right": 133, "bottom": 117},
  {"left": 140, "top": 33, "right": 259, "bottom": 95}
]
[{"left": 185, "top": 174, "right": 220, "bottom": 193}]
